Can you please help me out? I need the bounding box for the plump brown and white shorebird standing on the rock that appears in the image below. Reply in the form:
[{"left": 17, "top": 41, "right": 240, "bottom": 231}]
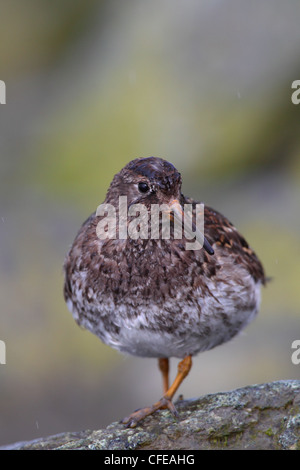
[{"left": 64, "top": 157, "right": 266, "bottom": 428}]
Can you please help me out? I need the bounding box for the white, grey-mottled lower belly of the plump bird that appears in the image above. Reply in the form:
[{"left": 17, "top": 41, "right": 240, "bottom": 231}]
[{"left": 83, "top": 276, "right": 260, "bottom": 358}]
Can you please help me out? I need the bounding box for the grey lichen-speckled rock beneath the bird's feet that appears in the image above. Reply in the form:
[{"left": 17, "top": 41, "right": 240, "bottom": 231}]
[{"left": 1, "top": 380, "right": 300, "bottom": 450}]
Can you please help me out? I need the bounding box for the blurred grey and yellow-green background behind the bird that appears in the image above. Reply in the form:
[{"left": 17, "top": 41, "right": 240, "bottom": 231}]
[{"left": 0, "top": 0, "right": 300, "bottom": 444}]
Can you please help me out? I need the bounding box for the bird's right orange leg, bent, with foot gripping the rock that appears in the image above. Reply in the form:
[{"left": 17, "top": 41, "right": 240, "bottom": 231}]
[{"left": 122, "top": 356, "right": 192, "bottom": 428}]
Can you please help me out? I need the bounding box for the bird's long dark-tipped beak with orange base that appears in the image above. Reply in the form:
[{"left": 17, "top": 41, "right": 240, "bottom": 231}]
[{"left": 168, "top": 199, "right": 214, "bottom": 255}]
